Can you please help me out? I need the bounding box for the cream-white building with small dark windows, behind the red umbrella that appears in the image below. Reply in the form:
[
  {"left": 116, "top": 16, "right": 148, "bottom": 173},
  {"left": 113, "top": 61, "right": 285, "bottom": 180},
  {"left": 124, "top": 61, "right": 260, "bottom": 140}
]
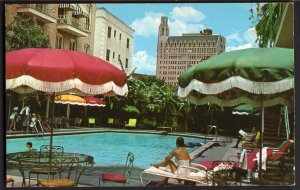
[{"left": 93, "top": 8, "right": 134, "bottom": 72}]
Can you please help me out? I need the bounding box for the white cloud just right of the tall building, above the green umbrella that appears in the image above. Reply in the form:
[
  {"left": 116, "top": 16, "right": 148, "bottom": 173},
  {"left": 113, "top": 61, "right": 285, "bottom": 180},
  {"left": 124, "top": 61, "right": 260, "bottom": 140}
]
[{"left": 225, "top": 27, "right": 258, "bottom": 52}]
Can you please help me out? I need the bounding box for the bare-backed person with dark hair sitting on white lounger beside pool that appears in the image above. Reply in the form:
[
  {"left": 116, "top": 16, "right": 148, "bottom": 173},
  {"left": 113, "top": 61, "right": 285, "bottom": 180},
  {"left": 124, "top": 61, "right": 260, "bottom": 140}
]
[{"left": 151, "top": 137, "right": 191, "bottom": 176}]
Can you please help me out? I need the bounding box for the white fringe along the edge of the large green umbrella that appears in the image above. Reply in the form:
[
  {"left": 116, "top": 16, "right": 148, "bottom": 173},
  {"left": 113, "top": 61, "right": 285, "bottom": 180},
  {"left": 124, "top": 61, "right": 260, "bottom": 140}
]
[{"left": 178, "top": 76, "right": 294, "bottom": 98}]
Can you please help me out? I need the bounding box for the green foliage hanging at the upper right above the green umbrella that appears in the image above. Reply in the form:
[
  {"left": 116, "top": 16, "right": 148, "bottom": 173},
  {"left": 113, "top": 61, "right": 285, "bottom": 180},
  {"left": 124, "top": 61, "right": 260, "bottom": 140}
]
[{"left": 249, "top": 3, "right": 285, "bottom": 47}]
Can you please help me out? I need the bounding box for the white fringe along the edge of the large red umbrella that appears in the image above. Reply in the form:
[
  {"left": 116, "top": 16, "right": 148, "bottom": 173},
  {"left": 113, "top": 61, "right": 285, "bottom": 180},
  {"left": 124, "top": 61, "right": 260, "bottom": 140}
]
[{"left": 6, "top": 75, "right": 128, "bottom": 96}]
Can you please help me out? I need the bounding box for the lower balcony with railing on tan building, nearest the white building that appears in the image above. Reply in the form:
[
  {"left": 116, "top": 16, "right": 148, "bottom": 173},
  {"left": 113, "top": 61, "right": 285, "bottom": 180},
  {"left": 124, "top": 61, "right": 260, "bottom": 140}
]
[{"left": 57, "top": 15, "right": 88, "bottom": 37}]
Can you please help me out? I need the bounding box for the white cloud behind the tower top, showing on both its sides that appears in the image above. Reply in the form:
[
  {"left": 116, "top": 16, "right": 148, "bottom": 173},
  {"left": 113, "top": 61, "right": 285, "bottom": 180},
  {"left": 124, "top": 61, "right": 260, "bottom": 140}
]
[{"left": 130, "top": 6, "right": 206, "bottom": 37}]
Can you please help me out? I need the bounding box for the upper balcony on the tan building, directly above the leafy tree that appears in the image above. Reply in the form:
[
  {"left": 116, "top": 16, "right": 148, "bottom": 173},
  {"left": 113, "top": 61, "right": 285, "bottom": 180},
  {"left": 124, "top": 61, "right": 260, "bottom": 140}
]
[{"left": 17, "top": 4, "right": 56, "bottom": 23}]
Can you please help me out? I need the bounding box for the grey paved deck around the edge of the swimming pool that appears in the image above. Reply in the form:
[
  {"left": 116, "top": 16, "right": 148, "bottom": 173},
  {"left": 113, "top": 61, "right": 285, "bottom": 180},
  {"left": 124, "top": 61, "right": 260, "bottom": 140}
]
[{"left": 6, "top": 127, "right": 244, "bottom": 187}]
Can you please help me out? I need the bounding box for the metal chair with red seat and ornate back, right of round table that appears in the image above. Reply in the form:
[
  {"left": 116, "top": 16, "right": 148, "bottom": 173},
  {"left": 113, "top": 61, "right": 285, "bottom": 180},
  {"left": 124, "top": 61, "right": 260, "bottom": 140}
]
[{"left": 99, "top": 152, "right": 134, "bottom": 187}]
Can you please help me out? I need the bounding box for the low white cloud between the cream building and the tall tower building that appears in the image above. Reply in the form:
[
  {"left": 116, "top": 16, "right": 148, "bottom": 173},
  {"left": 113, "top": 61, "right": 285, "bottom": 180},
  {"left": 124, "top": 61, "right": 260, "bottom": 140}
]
[{"left": 132, "top": 50, "right": 156, "bottom": 75}]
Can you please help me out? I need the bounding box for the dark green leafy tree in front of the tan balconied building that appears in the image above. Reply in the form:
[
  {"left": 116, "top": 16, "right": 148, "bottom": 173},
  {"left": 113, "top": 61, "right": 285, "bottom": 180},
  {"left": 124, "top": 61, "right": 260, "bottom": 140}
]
[{"left": 5, "top": 16, "right": 50, "bottom": 51}]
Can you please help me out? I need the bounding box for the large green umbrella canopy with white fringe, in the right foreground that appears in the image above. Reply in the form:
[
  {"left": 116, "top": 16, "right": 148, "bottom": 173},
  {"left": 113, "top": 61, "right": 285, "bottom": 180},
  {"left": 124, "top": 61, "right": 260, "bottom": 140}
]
[{"left": 178, "top": 48, "right": 294, "bottom": 107}]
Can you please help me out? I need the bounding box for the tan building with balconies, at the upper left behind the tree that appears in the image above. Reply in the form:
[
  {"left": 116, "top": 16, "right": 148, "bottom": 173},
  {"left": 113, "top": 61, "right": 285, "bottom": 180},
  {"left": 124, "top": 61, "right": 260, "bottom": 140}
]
[{"left": 5, "top": 4, "right": 96, "bottom": 54}]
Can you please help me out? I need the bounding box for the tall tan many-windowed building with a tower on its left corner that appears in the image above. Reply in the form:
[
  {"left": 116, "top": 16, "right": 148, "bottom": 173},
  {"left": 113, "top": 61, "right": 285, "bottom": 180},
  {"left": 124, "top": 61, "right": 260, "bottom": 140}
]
[{"left": 156, "top": 16, "right": 226, "bottom": 85}]
